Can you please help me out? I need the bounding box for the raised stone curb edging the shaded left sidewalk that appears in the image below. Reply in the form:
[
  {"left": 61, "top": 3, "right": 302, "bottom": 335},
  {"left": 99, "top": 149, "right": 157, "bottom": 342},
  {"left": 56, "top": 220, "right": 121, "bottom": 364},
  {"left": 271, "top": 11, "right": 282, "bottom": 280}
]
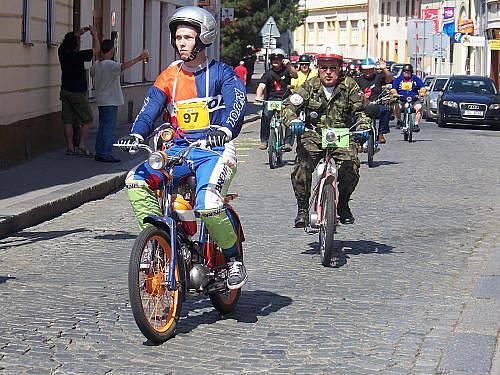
[{"left": 0, "top": 115, "right": 260, "bottom": 239}]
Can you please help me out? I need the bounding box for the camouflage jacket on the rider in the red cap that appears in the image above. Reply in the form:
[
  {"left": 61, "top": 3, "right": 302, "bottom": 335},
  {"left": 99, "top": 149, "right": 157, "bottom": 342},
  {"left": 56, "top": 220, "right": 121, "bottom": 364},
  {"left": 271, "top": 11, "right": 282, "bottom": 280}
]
[{"left": 283, "top": 77, "right": 371, "bottom": 129}]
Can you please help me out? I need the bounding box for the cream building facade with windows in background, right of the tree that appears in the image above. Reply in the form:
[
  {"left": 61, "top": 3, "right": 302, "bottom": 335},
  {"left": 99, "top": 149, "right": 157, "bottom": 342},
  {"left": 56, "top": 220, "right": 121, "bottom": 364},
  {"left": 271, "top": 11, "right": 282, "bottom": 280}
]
[{"left": 293, "top": 0, "right": 368, "bottom": 59}]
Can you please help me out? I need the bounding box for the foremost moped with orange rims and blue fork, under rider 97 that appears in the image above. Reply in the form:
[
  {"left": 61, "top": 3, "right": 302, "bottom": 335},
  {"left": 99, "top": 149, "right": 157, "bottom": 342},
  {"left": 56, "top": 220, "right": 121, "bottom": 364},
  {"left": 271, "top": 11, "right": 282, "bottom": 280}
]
[{"left": 114, "top": 134, "right": 245, "bottom": 344}]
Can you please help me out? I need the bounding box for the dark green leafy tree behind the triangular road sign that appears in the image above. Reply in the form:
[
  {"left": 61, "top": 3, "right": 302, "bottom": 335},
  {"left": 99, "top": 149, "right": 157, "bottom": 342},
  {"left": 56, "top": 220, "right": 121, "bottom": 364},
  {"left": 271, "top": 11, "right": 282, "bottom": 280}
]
[{"left": 221, "top": 0, "right": 305, "bottom": 66}]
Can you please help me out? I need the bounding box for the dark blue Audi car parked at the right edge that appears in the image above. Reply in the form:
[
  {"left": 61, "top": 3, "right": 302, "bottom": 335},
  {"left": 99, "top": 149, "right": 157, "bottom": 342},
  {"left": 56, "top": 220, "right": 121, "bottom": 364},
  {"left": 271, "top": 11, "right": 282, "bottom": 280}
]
[{"left": 438, "top": 76, "right": 500, "bottom": 129}]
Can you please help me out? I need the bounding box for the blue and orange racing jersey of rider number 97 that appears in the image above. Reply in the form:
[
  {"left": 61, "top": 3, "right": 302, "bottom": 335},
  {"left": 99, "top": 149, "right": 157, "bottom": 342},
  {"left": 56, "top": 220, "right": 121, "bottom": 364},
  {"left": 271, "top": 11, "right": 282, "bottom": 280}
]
[{"left": 132, "top": 60, "right": 246, "bottom": 141}]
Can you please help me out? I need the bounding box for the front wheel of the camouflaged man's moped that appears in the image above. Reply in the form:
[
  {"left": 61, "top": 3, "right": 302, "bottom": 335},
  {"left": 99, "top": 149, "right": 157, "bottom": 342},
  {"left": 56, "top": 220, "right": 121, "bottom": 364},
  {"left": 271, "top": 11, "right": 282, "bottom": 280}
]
[{"left": 319, "top": 184, "right": 336, "bottom": 267}]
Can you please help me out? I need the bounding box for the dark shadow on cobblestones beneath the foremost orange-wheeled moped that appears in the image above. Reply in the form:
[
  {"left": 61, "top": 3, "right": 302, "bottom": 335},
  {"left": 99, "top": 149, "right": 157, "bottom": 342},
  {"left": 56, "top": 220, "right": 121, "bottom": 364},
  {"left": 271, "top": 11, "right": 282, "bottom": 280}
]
[{"left": 144, "top": 290, "right": 292, "bottom": 346}]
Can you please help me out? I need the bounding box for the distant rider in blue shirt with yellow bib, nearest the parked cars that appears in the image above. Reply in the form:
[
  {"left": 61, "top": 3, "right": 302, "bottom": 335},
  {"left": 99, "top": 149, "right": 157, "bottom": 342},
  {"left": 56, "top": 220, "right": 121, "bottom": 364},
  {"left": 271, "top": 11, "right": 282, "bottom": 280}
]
[{"left": 392, "top": 64, "right": 425, "bottom": 132}]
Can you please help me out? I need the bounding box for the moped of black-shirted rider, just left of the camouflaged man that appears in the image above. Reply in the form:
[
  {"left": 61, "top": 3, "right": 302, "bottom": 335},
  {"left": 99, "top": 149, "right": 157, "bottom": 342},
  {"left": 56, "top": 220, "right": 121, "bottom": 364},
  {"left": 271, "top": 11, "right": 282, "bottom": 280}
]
[{"left": 257, "top": 100, "right": 285, "bottom": 169}]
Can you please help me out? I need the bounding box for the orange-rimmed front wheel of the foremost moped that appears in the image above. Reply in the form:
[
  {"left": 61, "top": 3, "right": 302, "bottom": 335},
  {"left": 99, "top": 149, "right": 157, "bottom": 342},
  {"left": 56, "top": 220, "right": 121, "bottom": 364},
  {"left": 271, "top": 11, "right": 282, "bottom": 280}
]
[{"left": 128, "top": 227, "right": 183, "bottom": 344}]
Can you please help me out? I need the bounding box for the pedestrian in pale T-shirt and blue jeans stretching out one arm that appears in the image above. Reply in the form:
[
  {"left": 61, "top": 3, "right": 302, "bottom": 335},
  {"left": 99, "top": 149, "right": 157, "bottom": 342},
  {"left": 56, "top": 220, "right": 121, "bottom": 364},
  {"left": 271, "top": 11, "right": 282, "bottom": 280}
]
[{"left": 90, "top": 39, "right": 149, "bottom": 163}]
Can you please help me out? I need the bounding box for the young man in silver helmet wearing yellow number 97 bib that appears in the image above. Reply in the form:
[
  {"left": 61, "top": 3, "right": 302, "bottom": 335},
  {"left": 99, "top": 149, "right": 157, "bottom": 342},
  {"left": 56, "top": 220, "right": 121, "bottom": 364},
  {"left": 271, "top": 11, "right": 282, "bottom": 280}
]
[{"left": 118, "top": 6, "right": 247, "bottom": 289}]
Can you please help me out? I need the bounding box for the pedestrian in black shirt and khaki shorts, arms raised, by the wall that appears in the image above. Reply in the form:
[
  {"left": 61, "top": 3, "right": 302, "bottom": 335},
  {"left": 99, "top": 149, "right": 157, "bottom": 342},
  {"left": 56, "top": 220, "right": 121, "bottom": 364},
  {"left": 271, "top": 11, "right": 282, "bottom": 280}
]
[{"left": 57, "top": 26, "right": 100, "bottom": 157}]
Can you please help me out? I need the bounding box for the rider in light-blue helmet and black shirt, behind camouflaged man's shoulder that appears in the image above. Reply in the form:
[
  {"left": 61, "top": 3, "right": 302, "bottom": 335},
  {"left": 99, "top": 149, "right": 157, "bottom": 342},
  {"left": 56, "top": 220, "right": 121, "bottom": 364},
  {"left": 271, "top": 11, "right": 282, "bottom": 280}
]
[{"left": 356, "top": 58, "right": 393, "bottom": 143}]
